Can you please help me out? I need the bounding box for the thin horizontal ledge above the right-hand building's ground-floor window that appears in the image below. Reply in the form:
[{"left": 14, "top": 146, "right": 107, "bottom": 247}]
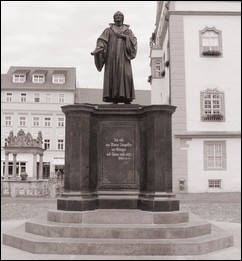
[{"left": 175, "top": 131, "right": 241, "bottom": 139}]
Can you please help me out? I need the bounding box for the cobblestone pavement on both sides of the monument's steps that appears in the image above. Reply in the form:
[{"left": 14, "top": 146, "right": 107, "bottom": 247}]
[{"left": 1, "top": 192, "right": 241, "bottom": 223}]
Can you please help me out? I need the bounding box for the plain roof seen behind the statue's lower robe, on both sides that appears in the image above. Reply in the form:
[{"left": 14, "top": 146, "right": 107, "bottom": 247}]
[{"left": 75, "top": 88, "right": 151, "bottom": 105}]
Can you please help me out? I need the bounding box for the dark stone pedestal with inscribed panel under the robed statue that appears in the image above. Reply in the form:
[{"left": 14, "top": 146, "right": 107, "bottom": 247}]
[{"left": 57, "top": 104, "right": 176, "bottom": 211}]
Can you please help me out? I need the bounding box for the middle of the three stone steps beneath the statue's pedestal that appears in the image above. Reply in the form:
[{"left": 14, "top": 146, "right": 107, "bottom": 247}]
[{"left": 25, "top": 218, "right": 211, "bottom": 239}]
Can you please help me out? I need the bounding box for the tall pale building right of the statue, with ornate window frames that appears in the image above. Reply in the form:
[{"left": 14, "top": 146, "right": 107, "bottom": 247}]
[{"left": 149, "top": 1, "right": 241, "bottom": 192}]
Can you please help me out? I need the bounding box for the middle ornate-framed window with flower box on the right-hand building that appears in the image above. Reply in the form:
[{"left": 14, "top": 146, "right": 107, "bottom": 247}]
[{"left": 201, "top": 89, "right": 225, "bottom": 121}]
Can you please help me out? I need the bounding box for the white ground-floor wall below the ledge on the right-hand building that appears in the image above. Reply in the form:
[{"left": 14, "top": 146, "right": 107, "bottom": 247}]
[{"left": 187, "top": 139, "right": 241, "bottom": 193}]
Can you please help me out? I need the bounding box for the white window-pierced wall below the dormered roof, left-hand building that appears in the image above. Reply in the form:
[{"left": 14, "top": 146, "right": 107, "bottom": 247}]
[{"left": 1, "top": 90, "right": 71, "bottom": 177}]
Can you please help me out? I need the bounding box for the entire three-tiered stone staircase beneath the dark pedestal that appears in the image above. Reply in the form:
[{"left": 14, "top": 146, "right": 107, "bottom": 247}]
[{"left": 3, "top": 209, "right": 233, "bottom": 255}]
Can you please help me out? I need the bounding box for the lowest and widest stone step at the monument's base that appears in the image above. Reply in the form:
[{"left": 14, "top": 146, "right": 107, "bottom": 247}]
[{"left": 3, "top": 222, "right": 233, "bottom": 255}]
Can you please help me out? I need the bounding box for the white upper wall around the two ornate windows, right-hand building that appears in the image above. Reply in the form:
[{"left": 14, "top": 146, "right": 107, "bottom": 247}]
[{"left": 184, "top": 16, "right": 241, "bottom": 131}]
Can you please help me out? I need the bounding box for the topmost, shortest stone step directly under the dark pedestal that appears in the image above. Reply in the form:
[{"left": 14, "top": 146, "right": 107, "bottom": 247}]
[{"left": 47, "top": 209, "right": 189, "bottom": 224}]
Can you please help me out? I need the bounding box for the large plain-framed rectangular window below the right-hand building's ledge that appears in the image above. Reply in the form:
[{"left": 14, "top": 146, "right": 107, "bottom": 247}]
[{"left": 204, "top": 141, "right": 226, "bottom": 170}]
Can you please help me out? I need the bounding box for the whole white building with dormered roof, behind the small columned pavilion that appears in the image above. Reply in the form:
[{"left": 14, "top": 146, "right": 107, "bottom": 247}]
[{"left": 1, "top": 66, "right": 76, "bottom": 178}]
